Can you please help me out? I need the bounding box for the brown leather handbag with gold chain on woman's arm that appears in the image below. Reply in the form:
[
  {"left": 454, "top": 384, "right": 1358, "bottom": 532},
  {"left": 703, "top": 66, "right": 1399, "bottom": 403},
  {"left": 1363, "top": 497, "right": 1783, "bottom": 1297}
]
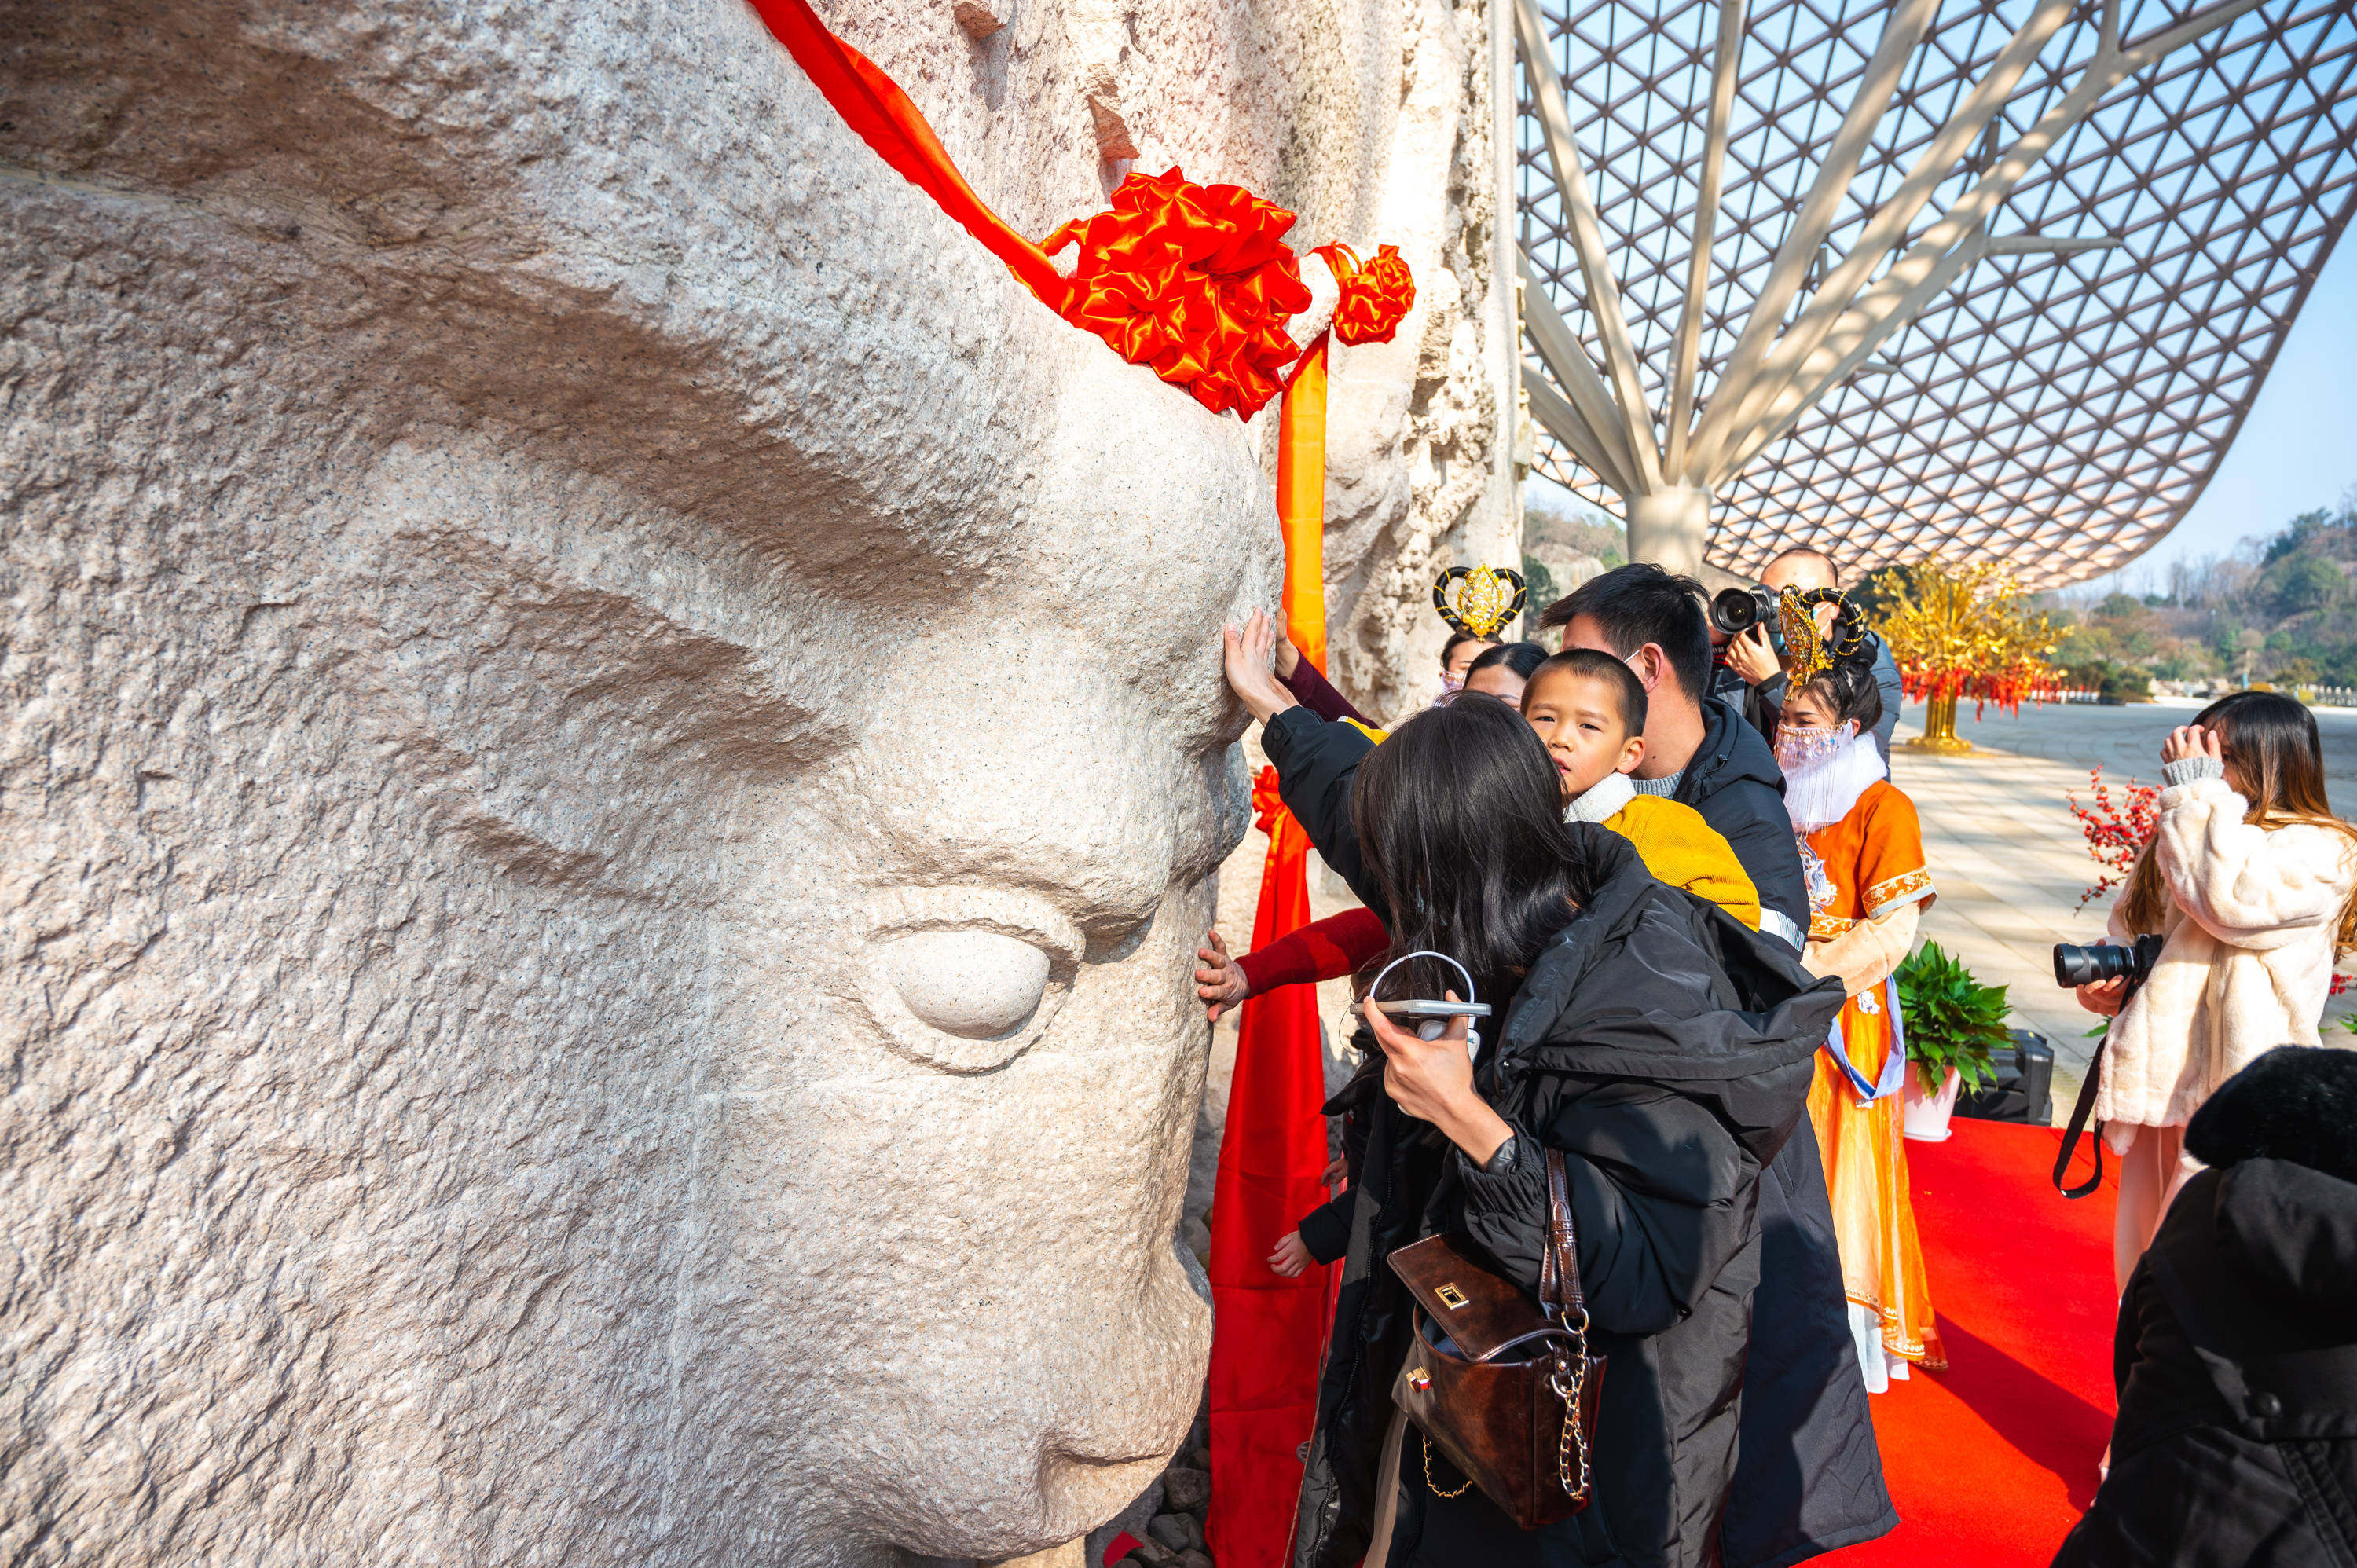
[{"left": 1391, "top": 1149, "right": 1605, "bottom": 1530}]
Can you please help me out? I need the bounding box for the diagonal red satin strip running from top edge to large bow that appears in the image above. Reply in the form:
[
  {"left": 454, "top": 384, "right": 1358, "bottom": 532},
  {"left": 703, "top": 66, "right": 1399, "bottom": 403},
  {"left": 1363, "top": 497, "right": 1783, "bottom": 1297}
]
[{"left": 752, "top": 0, "right": 1070, "bottom": 311}]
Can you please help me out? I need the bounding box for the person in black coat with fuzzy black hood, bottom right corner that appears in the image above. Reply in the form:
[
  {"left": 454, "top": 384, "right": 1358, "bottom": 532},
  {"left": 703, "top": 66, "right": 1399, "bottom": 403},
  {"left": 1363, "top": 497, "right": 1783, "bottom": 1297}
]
[{"left": 2055, "top": 1045, "right": 2357, "bottom": 1568}]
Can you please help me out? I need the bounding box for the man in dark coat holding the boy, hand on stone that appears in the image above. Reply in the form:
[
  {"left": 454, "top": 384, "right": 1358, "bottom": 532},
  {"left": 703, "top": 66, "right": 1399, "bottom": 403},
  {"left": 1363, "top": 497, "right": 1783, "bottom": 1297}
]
[{"left": 1228, "top": 601, "right": 1897, "bottom": 1568}]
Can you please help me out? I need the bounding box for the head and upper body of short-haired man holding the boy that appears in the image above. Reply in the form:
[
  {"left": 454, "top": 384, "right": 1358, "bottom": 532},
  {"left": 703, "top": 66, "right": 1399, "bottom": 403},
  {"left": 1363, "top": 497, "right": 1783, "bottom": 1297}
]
[{"left": 1539, "top": 563, "right": 1808, "bottom": 948}]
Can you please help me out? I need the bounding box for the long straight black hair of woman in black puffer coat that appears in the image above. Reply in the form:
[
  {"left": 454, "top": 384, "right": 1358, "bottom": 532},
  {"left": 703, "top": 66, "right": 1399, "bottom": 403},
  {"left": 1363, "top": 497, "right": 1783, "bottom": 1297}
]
[{"left": 1351, "top": 691, "right": 1596, "bottom": 1002}]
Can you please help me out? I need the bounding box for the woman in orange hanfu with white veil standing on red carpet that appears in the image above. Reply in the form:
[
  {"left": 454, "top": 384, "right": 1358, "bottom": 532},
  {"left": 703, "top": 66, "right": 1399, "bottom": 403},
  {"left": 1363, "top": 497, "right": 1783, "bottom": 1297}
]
[{"left": 1777, "top": 627, "right": 1947, "bottom": 1394}]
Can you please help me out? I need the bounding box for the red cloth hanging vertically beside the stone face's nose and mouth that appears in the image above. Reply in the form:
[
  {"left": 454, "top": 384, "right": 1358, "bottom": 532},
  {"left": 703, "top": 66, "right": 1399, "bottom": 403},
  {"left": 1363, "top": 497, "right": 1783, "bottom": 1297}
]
[{"left": 1204, "top": 768, "right": 1332, "bottom": 1568}]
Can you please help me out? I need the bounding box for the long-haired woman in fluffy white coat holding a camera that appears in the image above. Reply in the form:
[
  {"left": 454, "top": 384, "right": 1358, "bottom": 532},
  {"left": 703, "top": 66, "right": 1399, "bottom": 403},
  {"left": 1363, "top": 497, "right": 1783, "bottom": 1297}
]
[{"left": 2079, "top": 691, "right": 2357, "bottom": 1290}]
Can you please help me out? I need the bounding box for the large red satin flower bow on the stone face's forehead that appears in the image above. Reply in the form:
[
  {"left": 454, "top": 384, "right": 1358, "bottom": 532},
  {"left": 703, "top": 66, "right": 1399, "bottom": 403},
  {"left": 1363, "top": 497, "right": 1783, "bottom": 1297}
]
[{"left": 1042, "top": 170, "right": 1310, "bottom": 419}]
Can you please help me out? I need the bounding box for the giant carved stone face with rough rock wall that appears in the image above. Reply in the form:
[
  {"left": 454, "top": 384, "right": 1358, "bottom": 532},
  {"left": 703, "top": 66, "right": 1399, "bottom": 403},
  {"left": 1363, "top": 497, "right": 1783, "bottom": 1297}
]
[{"left": 0, "top": 0, "right": 1511, "bottom": 1566}]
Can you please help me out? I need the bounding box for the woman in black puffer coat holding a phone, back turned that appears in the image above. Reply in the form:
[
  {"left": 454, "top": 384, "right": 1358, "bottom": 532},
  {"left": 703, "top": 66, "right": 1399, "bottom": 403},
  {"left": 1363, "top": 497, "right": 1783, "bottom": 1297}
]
[{"left": 1294, "top": 695, "right": 1841, "bottom": 1568}]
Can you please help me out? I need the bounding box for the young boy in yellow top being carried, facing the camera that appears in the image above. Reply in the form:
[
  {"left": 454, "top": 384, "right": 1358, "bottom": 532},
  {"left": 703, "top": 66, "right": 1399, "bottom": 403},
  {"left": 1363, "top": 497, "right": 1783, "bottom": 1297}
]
[{"left": 1523, "top": 648, "right": 1761, "bottom": 932}]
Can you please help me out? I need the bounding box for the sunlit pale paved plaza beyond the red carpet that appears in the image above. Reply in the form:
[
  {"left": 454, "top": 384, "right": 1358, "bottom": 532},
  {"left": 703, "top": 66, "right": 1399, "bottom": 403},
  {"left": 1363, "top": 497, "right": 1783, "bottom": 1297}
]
[{"left": 1890, "top": 700, "right": 2357, "bottom": 1123}]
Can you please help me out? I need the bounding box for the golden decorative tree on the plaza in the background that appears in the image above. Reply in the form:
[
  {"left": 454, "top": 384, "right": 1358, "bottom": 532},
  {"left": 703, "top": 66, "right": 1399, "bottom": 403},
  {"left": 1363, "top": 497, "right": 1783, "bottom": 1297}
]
[{"left": 1874, "top": 561, "right": 2055, "bottom": 752}]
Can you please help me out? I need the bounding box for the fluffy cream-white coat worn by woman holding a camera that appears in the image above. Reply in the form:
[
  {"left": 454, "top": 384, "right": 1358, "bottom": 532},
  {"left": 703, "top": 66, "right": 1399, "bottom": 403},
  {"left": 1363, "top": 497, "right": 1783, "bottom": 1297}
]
[{"left": 2095, "top": 764, "right": 2357, "bottom": 1149}]
